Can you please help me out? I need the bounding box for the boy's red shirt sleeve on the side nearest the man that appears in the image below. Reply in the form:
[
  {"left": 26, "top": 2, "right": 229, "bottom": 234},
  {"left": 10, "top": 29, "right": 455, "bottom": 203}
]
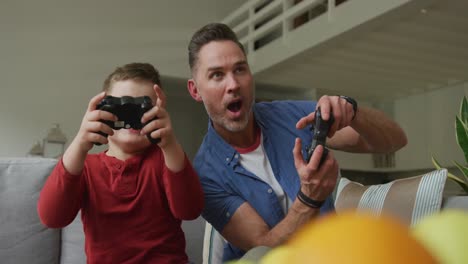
[{"left": 162, "top": 156, "right": 203, "bottom": 220}]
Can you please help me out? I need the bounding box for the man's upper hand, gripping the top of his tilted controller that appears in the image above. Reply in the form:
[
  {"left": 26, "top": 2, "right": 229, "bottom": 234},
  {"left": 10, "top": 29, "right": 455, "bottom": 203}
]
[{"left": 296, "top": 95, "right": 357, "bottom": 137}]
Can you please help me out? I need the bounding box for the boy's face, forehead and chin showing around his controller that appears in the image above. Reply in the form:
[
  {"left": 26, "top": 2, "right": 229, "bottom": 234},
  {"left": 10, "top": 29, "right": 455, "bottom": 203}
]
[{"left": 107, "top": 80, "right": 157, "bottom": 152}]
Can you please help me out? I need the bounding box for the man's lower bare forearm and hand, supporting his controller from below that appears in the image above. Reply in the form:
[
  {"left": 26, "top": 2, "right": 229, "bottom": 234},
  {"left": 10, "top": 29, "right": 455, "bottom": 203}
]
[{"left": 221, "top": 139, "right": 338, "bottom": 251}]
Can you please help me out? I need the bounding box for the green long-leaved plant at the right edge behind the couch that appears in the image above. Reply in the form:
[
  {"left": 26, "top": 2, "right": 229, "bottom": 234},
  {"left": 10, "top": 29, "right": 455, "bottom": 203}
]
[{"left": 432, "top": 97, "right": 468, "bottom": 194}]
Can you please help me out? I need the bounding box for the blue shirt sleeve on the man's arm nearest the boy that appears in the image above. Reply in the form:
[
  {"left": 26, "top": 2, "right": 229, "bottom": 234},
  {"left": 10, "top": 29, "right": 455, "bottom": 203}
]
[{"left": 202, "top": 175, "right": 246, "bottom": 233}]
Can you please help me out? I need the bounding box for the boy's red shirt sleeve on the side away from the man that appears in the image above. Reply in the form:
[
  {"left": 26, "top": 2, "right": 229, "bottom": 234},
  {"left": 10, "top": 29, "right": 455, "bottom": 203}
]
[{"left": 37, "top": 160, "right": 85, "bottom": 228}]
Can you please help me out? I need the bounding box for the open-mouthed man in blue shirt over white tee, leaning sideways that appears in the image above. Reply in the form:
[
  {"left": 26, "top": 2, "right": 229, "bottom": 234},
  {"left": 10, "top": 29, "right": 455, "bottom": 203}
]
[{"left": 187, "top": 23, "right": 406, "bottom": 261}]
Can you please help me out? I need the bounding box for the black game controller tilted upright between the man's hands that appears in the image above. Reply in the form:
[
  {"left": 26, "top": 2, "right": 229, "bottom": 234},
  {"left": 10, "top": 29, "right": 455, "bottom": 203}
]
[{"left": 306, "top": 107, "right": 335, "bottom": 168}]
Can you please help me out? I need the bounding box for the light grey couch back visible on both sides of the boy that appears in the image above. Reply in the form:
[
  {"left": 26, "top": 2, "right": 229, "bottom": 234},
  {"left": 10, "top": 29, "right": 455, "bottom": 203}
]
[{"left": 0, "top": 158, "right": 204, "bottom": 264}]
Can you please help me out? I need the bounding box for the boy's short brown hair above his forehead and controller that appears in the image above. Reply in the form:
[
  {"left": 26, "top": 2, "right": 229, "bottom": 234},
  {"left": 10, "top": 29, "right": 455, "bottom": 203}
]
[{"left": 102, "top": 62, "right": 162, "bottom": 92}]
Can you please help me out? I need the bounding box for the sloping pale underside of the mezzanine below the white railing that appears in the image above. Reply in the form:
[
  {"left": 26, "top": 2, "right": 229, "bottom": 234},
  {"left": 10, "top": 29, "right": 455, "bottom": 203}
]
[{"left": 252, "top": 0, "right": 468, "bottom": 102}]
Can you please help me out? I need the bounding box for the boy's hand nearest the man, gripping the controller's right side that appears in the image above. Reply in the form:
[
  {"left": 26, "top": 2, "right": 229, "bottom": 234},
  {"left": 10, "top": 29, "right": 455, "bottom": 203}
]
[{"left": 140, "top": 84, "right": 177, "bottom": 149}]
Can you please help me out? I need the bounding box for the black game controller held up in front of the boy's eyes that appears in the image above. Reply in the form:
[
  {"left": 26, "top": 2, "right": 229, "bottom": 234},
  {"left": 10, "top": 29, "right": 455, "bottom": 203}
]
[{"left": 95, "top": 95, "right": 161, "bottom": 145}]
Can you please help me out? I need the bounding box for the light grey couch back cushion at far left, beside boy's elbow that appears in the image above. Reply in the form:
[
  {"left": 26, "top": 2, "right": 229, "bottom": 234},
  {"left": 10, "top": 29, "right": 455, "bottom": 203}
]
[{"left": 0, "top": 158, "right": 60, "bottom": 264}]
